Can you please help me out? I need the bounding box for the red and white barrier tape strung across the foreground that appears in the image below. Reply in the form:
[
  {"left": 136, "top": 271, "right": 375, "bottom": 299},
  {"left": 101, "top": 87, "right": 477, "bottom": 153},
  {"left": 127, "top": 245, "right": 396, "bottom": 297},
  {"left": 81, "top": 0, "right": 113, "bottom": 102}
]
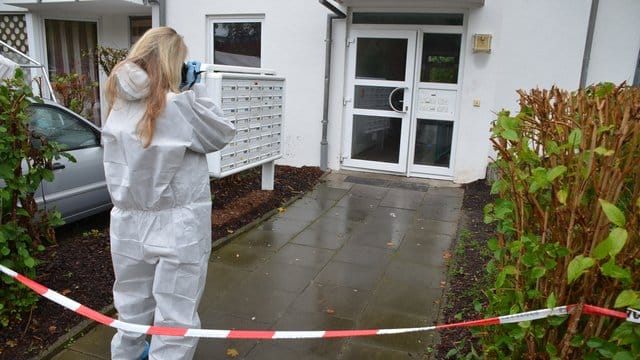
[{"left": 0, "top": 265, "right": 640, "bottom": 340}]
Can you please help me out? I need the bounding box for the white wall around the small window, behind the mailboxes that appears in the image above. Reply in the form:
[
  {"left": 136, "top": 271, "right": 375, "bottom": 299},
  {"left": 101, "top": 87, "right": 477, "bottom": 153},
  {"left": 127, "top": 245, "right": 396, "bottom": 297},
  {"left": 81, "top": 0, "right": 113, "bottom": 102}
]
[{"left": 166, "top": 0, "right": 327, "bottom": 166}]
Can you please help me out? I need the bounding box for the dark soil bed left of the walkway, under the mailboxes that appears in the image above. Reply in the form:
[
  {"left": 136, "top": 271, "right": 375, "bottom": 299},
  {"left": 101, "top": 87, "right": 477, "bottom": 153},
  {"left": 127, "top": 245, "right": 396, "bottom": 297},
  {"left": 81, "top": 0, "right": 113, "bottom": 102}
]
[{"left": 0, "top": 166, "right": 322, "bottom": 360}]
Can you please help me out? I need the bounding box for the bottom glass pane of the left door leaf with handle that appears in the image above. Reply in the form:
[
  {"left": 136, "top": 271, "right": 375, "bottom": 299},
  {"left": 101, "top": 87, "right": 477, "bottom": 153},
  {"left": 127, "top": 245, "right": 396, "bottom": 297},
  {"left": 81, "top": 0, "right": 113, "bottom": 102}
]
[{"left": 351, "top": 115, "right": 402, "bottom": 163}]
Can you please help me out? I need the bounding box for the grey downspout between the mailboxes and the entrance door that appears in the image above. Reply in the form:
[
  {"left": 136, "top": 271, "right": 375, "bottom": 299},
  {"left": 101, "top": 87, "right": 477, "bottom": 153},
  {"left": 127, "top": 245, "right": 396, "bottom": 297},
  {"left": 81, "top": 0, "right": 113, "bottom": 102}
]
[{"left": 318, "top": 0, "right": 347, "bottom": 171}]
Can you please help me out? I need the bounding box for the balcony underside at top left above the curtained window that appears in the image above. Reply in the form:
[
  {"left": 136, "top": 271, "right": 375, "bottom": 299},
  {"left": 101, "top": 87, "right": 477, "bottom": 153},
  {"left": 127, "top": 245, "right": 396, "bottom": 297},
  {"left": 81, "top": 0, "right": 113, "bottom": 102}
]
[{"left": 4, "top": 0, "right": 151, "bottom": 15}]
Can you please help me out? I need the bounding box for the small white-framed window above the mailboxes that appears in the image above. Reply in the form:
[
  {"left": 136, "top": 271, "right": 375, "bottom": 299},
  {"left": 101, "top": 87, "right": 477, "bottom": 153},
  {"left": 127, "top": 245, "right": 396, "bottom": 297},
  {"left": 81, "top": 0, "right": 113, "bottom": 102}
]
[{"left": 208, "top": 15, "right": 264, "bottom": 67}]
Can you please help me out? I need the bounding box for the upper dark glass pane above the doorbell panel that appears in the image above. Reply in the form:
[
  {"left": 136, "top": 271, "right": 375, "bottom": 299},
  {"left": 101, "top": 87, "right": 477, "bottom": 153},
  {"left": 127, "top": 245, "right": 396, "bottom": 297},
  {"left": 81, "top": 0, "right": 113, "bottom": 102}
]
[{"left": 420, "top": 34, "right": 462, "bottom": 84}]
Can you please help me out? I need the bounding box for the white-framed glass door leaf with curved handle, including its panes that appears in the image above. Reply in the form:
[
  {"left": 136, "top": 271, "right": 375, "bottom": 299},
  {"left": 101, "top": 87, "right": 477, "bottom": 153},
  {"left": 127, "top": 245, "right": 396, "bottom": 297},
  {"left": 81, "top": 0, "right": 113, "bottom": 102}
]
[{"left": 343, "top": 30, "right": 417, "bottom": 172}]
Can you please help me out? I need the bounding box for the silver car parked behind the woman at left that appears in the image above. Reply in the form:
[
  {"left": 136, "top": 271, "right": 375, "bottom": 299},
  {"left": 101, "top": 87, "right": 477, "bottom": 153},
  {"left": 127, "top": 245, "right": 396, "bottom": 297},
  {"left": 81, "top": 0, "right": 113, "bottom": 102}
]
[{"left": 29, "top": 100, "right": 111, "bottom": 223}]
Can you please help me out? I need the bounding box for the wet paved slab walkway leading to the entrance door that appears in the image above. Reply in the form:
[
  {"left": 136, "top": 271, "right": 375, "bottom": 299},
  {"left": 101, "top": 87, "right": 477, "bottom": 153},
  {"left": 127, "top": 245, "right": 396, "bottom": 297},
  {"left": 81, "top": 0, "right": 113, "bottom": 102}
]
[{"left": 55, "top": 173, "right": 463, "bottom": 360}]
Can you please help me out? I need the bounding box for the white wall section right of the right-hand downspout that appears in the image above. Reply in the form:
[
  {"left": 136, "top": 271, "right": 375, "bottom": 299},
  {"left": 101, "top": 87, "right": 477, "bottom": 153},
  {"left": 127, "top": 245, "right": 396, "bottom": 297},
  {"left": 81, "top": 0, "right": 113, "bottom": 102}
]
[{"left": 587, "top": 0, "right": 640, "bottom": 85}]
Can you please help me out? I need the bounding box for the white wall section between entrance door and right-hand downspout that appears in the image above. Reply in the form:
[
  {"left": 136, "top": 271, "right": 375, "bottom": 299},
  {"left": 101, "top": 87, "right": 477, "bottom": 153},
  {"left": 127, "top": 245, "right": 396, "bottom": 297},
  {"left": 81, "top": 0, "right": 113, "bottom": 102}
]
[{"left": 454, "top": 0, "right": 591, "bottom": 183}]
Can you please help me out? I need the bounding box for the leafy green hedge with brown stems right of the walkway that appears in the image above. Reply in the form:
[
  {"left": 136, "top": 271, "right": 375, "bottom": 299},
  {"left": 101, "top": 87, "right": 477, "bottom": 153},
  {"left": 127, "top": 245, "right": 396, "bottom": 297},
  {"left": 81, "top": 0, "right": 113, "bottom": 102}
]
[{"left": 483, "top": 84, "right": 640, "bottom": 359}]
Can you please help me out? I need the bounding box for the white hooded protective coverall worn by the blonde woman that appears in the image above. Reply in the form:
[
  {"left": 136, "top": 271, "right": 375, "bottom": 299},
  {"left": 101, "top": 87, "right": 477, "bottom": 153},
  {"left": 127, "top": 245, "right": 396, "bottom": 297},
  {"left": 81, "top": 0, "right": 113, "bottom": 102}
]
[{"left": 102, "top": 63, "right": 235, "bottom": 360}]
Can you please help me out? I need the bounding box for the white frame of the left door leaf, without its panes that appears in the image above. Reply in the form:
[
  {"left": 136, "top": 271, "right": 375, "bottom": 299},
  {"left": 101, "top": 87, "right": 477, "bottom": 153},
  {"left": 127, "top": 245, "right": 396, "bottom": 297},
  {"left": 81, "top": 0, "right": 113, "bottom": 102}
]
[{"left": 342, "top": 29, "right": 417, "bottom": 173}]
